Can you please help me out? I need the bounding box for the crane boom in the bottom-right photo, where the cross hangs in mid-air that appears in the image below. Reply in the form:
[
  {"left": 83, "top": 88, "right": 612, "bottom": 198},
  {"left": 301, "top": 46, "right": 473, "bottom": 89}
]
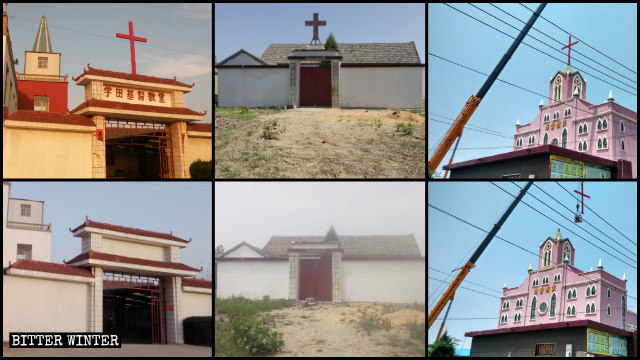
[{"left": 429, "top": 181, "right": 533, "bottom": 328}]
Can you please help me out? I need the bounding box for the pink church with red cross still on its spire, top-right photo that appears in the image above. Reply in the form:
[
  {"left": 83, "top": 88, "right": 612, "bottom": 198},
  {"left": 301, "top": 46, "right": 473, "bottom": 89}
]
[{"left": 513, "top": 65, "right": 638, "bottom": 178}]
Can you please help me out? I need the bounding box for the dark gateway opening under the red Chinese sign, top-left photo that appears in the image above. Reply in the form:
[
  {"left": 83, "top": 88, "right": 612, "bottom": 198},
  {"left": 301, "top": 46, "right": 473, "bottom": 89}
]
[{"left": 105, "top": 120, "right": 174, "bottom": 179}]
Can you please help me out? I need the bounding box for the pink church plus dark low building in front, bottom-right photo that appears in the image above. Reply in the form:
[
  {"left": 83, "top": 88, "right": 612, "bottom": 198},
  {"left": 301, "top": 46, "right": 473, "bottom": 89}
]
[{"left": 465, "top": 229, "right": 638, "bottom": 357}]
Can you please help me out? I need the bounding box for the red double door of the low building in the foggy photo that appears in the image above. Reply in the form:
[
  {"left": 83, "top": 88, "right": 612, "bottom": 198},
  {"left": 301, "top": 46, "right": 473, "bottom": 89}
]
[{"left": 300, "top": 259, "right": 332, "bottom": 301}]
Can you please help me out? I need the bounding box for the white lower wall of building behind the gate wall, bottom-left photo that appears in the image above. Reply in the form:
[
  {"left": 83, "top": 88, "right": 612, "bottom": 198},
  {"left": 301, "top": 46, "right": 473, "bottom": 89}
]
[{"left": 2, "top": 228, "right": 51, "bottom": 267}]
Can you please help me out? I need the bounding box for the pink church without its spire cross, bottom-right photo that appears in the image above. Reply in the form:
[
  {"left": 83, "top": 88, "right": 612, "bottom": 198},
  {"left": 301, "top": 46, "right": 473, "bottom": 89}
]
[{"left": 500, "top": 231, "right": 637, "bottom": 332}]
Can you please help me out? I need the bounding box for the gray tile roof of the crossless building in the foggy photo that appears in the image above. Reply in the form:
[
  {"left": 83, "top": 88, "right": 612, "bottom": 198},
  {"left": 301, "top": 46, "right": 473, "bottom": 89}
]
[{"left": 263, "top": 235, "right": 421, "bottom": 257}]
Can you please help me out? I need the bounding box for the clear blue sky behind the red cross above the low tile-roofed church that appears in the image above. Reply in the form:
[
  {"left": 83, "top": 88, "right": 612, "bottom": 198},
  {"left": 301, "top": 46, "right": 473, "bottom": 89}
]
[{"left": 215, "top": 4, "right": 426, "bottom": 63}]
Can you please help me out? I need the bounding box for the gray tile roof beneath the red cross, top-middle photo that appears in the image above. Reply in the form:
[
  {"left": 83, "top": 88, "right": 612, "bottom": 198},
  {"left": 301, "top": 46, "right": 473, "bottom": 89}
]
[{"left": 260, "top": 41, "right": 420, "bottom": 65}]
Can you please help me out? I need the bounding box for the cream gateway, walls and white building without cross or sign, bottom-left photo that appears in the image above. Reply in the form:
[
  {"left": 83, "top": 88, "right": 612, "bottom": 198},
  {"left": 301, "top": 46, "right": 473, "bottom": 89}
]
[{"left": 2, "top": 182, "right": 212, "bottom": 344}]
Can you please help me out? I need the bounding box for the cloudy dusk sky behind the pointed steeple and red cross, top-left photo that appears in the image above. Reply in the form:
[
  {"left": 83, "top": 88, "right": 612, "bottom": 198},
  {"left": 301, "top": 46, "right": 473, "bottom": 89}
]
[{"left": 3, "top": 3, "right": 213, "bottom": 123}]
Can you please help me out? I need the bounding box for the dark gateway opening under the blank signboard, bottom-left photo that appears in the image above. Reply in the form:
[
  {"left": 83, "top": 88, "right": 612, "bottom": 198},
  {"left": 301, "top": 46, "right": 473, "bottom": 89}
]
[{"left": 102, "top": 272, "right": 165, "bottom": 344}]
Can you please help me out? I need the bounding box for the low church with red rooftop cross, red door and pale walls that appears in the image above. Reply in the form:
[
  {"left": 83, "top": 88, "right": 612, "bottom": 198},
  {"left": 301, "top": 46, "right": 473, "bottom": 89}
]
[{"left": 216, "top": 13, "right": 425, "bottom": 108}]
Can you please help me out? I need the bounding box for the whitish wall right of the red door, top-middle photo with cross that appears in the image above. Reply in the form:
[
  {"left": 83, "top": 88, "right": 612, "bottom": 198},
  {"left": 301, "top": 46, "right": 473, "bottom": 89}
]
[{"left": 340, "top": 67, "right": 424, "bottom": 109}]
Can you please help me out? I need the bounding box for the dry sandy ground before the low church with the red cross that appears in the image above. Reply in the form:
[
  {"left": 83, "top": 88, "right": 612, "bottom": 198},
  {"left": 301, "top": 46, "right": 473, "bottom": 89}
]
[{"left": 215, "top": 108, "right": 425, "bottom": 178}]
